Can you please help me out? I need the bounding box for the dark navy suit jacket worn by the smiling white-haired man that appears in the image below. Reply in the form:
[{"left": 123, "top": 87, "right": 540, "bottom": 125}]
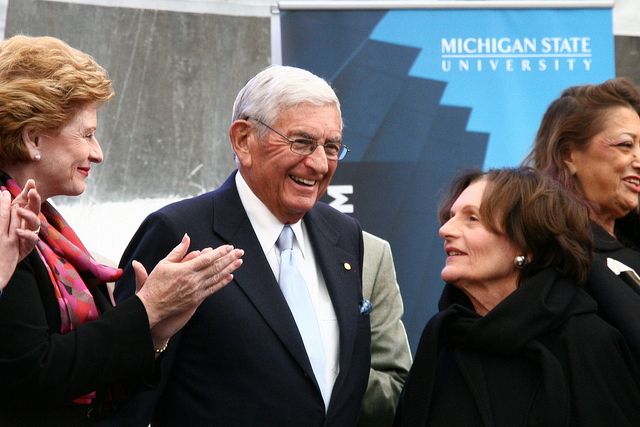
[{"left": 110, "top": 174, "right": 370, "bottom": 427}]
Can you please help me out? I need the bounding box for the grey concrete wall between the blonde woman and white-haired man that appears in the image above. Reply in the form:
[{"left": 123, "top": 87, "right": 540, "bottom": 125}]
[{"left": 5, "top": 0, "right": 270, "bottom": 202}]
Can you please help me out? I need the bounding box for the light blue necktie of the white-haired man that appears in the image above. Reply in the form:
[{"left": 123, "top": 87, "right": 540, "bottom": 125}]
[{"left": 277, "top": 225, "right": 329, "bottom": 410}]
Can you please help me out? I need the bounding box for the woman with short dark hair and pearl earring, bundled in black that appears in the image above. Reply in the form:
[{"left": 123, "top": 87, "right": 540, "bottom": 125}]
[{"left": 395, "top": 168, "right": 640, "bottom": 426}]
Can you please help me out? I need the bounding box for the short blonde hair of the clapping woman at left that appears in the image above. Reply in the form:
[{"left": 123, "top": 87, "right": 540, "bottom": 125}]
[{"left": 0, "top": 36, "right": 115, "bottom": 167}]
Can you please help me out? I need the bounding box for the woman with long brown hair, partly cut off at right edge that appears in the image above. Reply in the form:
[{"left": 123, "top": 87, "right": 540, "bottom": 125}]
[{"left": 525, "top": 78, "right": 640, "bottom": 361}]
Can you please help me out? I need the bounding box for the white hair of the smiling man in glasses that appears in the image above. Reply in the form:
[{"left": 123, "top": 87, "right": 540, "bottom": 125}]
[{"left": 232, "top": 65, "right": 342, "bottom": 137}]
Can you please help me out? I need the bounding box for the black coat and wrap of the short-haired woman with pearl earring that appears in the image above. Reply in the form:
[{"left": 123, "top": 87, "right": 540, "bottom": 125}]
[{"left": 394, "top": 270, "right": 640, "bottom": 426}]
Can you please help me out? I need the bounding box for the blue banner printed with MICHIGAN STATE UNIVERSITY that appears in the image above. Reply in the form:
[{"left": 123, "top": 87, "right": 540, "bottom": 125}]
[{"left": 272, "top": 2, "right": 615, "bottom": 349}]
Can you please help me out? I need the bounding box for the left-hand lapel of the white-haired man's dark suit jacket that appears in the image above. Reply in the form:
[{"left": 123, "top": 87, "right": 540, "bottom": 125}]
[{"left": 213, "top": 174, "right": 320, "bottom": 386}]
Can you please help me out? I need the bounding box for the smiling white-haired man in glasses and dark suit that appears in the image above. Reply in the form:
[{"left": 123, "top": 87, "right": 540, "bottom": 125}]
[{"left": 110, "top": 66, "right": 370, "bottom": 427}]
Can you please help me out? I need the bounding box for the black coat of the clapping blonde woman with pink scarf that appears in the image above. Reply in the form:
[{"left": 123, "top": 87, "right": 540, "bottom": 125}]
[{"left": 0, "top": 250, "right": 155, "bottom": 426}]
